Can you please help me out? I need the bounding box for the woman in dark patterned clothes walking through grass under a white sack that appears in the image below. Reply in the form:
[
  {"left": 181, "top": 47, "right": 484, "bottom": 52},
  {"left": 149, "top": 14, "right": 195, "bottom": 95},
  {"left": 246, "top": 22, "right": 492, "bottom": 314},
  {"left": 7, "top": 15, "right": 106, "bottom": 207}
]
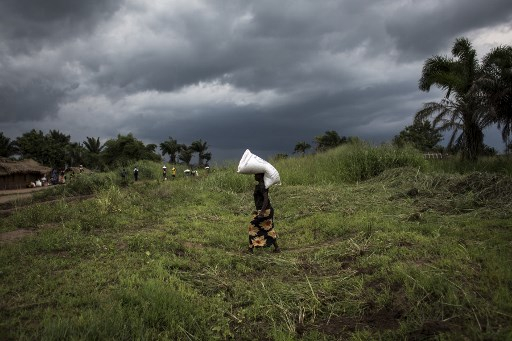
[{"left": 249, "top": 173, "right": 281, "bottom": 253}]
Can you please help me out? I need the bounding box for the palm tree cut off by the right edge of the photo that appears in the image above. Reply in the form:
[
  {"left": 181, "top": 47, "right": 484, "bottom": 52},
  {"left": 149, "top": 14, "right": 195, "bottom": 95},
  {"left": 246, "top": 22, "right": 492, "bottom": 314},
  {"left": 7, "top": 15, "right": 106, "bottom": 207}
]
[{"left": 477, "top": 46, "right": 512, "bottom": 145}]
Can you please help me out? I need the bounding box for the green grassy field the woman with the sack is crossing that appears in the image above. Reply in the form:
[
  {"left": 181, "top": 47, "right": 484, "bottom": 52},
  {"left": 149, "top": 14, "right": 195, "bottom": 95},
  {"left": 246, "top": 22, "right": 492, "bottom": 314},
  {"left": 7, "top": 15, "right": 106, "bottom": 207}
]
[{"left": 0, "top": 145, "right": 512, "bottom": 340}]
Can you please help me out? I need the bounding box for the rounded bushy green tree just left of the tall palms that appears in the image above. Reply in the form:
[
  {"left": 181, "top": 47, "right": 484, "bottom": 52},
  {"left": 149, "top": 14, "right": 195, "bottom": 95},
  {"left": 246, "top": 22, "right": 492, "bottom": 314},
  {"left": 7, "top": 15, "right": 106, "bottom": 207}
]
[{"left": 393, "top": 119, "right": 442, "bottom": 151}]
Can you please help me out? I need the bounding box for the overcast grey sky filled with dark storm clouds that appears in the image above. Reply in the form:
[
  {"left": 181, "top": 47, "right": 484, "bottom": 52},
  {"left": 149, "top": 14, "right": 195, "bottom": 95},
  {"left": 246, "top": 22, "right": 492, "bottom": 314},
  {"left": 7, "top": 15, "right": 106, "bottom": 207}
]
[{"left": 0, "top": 0, "right": 512, "bottom": 161}]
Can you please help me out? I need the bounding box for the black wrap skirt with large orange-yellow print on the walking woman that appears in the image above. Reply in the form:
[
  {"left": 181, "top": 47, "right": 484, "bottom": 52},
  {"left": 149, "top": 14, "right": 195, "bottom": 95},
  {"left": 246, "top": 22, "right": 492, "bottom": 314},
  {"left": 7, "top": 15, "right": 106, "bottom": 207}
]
[{"left": 249, "top": 208, "right": 277, "bottom": 249}]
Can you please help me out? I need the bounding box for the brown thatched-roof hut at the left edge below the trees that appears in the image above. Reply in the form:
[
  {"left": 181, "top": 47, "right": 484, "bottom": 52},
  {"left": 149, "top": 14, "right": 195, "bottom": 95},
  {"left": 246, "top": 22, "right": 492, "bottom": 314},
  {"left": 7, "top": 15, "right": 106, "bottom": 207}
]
[{"left": 0, "top": 158, "right": 51, "bottom": 189}]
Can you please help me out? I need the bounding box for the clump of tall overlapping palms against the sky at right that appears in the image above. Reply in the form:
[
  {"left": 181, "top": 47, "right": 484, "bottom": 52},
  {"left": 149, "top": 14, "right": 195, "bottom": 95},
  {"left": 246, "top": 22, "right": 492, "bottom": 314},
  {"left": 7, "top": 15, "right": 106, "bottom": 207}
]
[{"left": 416, "top": 38, "right": 512, "bottom": 160}]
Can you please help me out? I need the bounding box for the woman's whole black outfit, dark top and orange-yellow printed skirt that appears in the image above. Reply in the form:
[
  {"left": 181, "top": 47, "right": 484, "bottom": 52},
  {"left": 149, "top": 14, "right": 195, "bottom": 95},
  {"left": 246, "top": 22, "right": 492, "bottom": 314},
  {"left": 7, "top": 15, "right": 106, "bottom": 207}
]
[{"left": 249, "top": 183, "right": 277, "bottom": 249}]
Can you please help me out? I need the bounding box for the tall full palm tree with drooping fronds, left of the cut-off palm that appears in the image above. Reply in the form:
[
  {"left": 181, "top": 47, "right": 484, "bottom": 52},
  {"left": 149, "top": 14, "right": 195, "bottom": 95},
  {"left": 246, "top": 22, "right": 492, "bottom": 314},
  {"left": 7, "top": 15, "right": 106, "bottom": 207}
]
[{"left": 416, "top": 38, "right": 490, "bottom": 160}]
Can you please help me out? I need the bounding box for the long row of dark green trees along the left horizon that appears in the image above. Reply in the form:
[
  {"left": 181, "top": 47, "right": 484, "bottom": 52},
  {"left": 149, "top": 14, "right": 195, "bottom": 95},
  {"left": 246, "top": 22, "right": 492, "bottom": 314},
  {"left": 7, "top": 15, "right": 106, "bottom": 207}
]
[{"left": 0, "top": 129, "right": 212, "bottom": 170}]
